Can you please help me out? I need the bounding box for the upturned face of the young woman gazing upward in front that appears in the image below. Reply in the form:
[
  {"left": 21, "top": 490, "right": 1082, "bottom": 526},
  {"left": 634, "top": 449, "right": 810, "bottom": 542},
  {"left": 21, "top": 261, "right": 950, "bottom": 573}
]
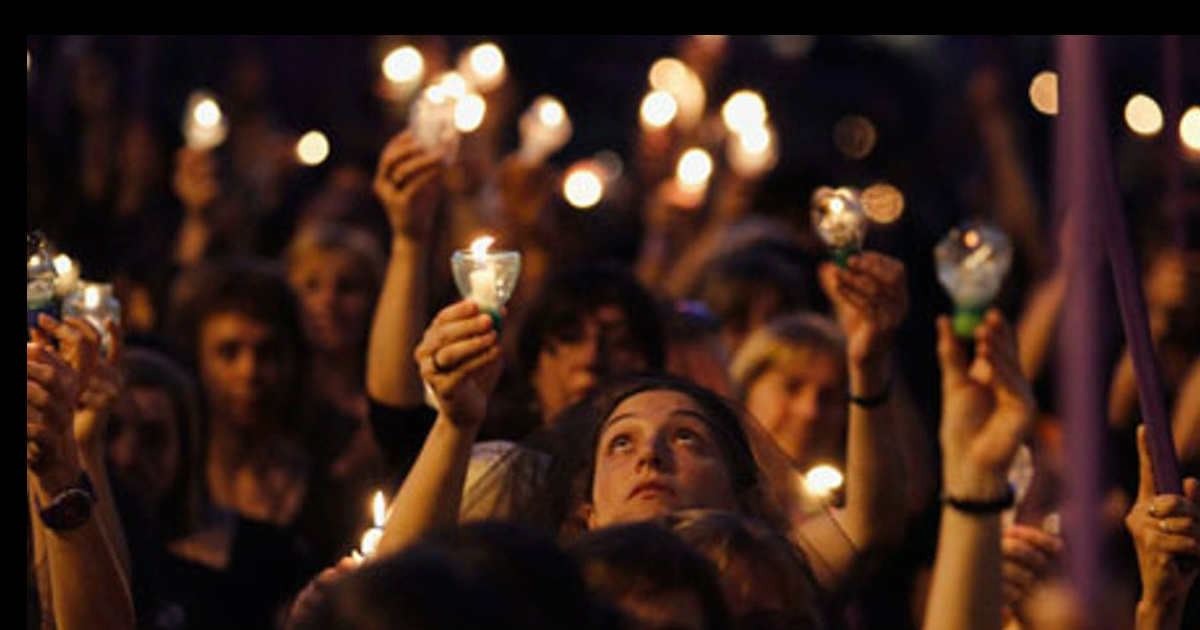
[{"left": 587, "top": 390, "right": 737, "bottom": 529}]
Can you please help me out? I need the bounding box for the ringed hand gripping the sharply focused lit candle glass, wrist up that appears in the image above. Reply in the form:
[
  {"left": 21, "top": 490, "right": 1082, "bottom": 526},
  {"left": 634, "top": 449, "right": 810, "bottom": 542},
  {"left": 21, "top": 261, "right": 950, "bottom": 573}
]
[{"left": 413, "top": 300, "right": 503, "bottom": 427}]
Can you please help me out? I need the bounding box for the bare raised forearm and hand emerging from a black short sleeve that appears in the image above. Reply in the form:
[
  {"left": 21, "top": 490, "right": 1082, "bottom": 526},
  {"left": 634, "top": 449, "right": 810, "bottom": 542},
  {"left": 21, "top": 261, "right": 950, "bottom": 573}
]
[{"left": 367, "top": 131, "right": 444, "bottom": 407}]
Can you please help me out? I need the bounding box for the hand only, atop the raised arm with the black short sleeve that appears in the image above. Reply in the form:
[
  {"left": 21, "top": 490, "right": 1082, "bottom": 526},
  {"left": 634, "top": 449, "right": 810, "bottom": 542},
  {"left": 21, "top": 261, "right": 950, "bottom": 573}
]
[{"left": 373, "top": 130, "right": 445, "bottom": 241}]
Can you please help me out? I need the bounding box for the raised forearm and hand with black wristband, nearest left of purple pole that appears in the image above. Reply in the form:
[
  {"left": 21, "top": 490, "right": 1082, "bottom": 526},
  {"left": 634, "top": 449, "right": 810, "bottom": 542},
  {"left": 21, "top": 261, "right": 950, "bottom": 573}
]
[{"left": 923, "top": 311, "right": 1036, "bottom": 630}]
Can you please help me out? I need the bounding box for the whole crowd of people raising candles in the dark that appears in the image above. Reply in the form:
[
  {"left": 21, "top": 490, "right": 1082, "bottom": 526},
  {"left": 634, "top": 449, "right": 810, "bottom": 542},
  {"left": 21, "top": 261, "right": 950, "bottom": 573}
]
[{"left": 26, "top": 36, "right": 1200, "bottom": 630}]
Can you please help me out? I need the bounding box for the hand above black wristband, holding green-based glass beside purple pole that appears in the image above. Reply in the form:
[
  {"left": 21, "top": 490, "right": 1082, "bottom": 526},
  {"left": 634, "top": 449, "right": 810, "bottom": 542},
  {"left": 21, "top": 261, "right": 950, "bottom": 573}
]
[{"left": 937, "top": 310, "right": 1036, "bottom": 500}]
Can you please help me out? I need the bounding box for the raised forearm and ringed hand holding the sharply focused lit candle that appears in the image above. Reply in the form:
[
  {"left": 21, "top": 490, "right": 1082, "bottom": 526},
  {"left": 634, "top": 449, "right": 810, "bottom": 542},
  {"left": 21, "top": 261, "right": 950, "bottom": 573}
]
[{"left": 379, "top": 300, "right": 503, "bottom": 553}]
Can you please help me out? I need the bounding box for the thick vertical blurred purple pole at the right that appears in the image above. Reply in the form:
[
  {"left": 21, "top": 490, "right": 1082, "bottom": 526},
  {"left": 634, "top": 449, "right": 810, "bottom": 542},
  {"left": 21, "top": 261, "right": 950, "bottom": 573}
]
[{"left": 1055, "top": 35, "right": 1106, "bottom": 630}]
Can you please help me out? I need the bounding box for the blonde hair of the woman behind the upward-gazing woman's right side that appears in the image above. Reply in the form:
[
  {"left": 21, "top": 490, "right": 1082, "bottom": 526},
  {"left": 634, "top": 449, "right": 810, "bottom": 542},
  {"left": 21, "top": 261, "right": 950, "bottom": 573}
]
[{"left": 730, "top": 312, "right": 846, "bottom": 400}]
